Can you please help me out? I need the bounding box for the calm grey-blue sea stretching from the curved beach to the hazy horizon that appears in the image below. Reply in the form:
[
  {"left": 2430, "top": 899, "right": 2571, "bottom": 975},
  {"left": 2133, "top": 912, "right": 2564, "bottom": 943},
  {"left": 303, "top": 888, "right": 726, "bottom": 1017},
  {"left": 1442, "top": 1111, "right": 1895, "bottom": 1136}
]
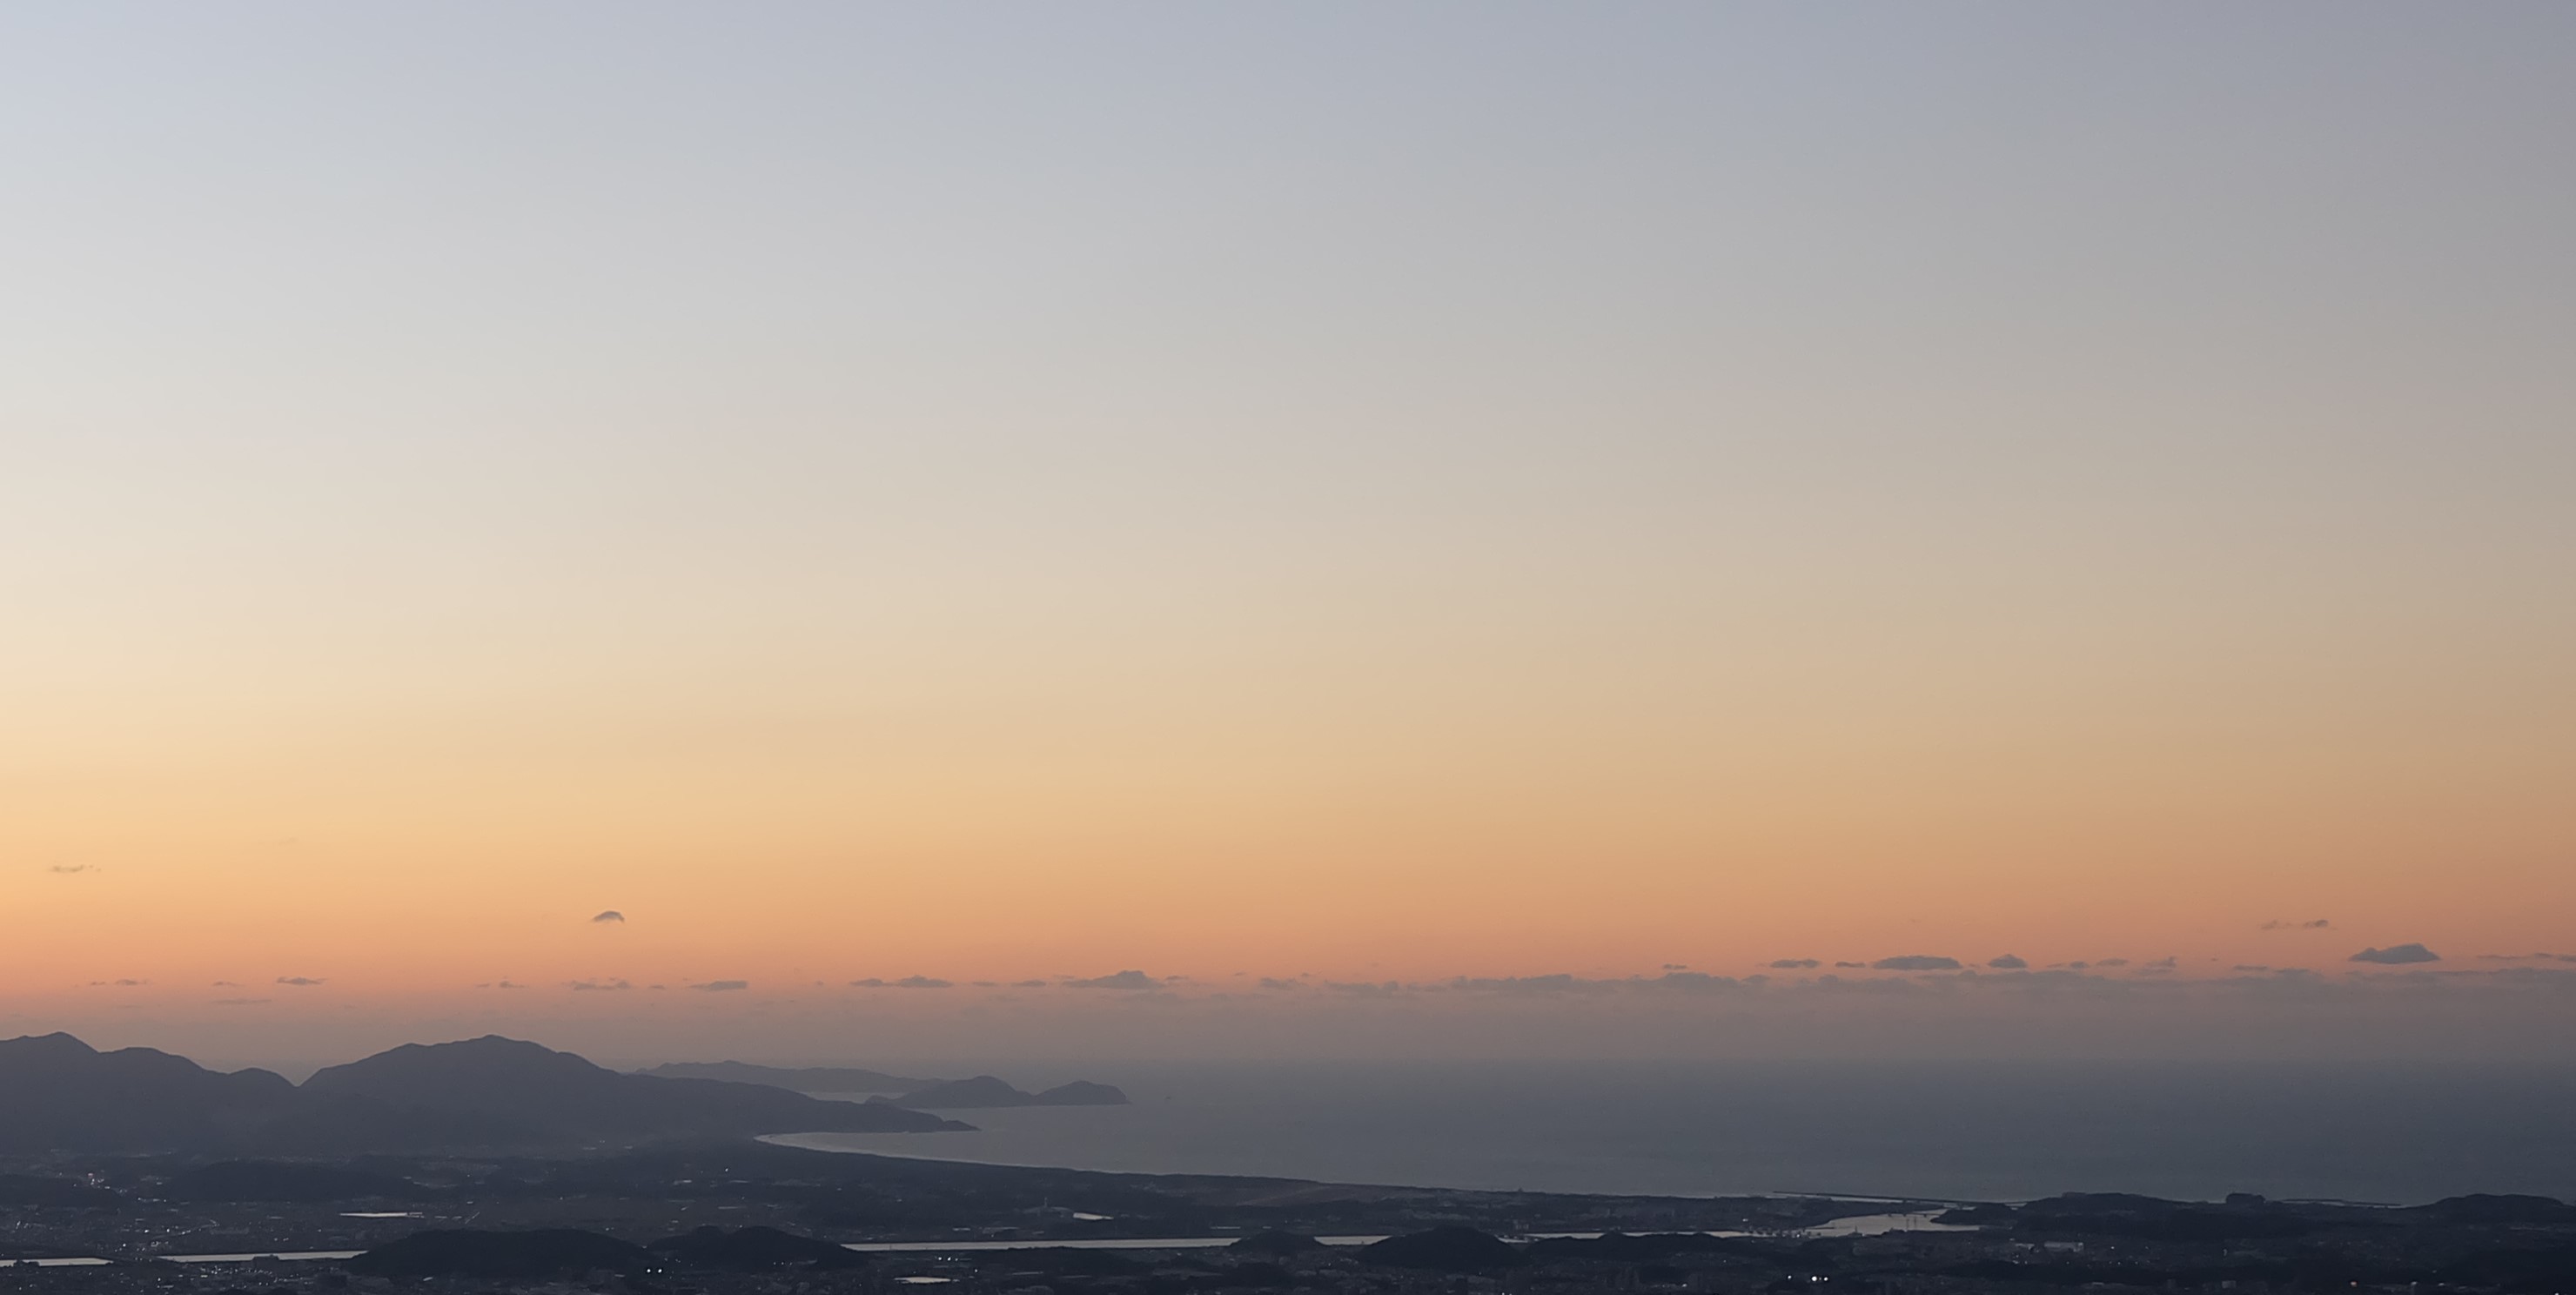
[{"left": 781, "top": 1064, "right": 2576, "bottom": 1204}]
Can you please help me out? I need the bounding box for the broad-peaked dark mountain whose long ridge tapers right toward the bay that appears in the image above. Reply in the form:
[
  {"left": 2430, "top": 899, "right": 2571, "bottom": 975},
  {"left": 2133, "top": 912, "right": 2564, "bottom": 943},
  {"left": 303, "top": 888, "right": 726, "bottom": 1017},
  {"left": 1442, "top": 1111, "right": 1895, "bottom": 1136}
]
[{"left": 301, "top": 1035, "right": 966, "bottom": 1141}]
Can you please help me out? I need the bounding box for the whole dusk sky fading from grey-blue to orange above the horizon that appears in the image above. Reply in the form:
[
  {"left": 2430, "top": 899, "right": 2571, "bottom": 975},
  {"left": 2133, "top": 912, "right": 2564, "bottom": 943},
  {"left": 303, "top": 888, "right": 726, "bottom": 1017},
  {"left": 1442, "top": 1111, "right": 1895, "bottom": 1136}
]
[{"left": 0, "top": 3, "right": 2576, "bottom": 1076}]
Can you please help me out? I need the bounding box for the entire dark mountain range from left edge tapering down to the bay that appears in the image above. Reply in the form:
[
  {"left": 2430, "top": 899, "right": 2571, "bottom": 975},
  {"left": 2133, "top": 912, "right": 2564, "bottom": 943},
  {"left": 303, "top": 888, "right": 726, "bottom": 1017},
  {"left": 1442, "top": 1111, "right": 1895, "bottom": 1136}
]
[{"left": 0, "top": 1035, "right": 969, "bottom": 1156}]
